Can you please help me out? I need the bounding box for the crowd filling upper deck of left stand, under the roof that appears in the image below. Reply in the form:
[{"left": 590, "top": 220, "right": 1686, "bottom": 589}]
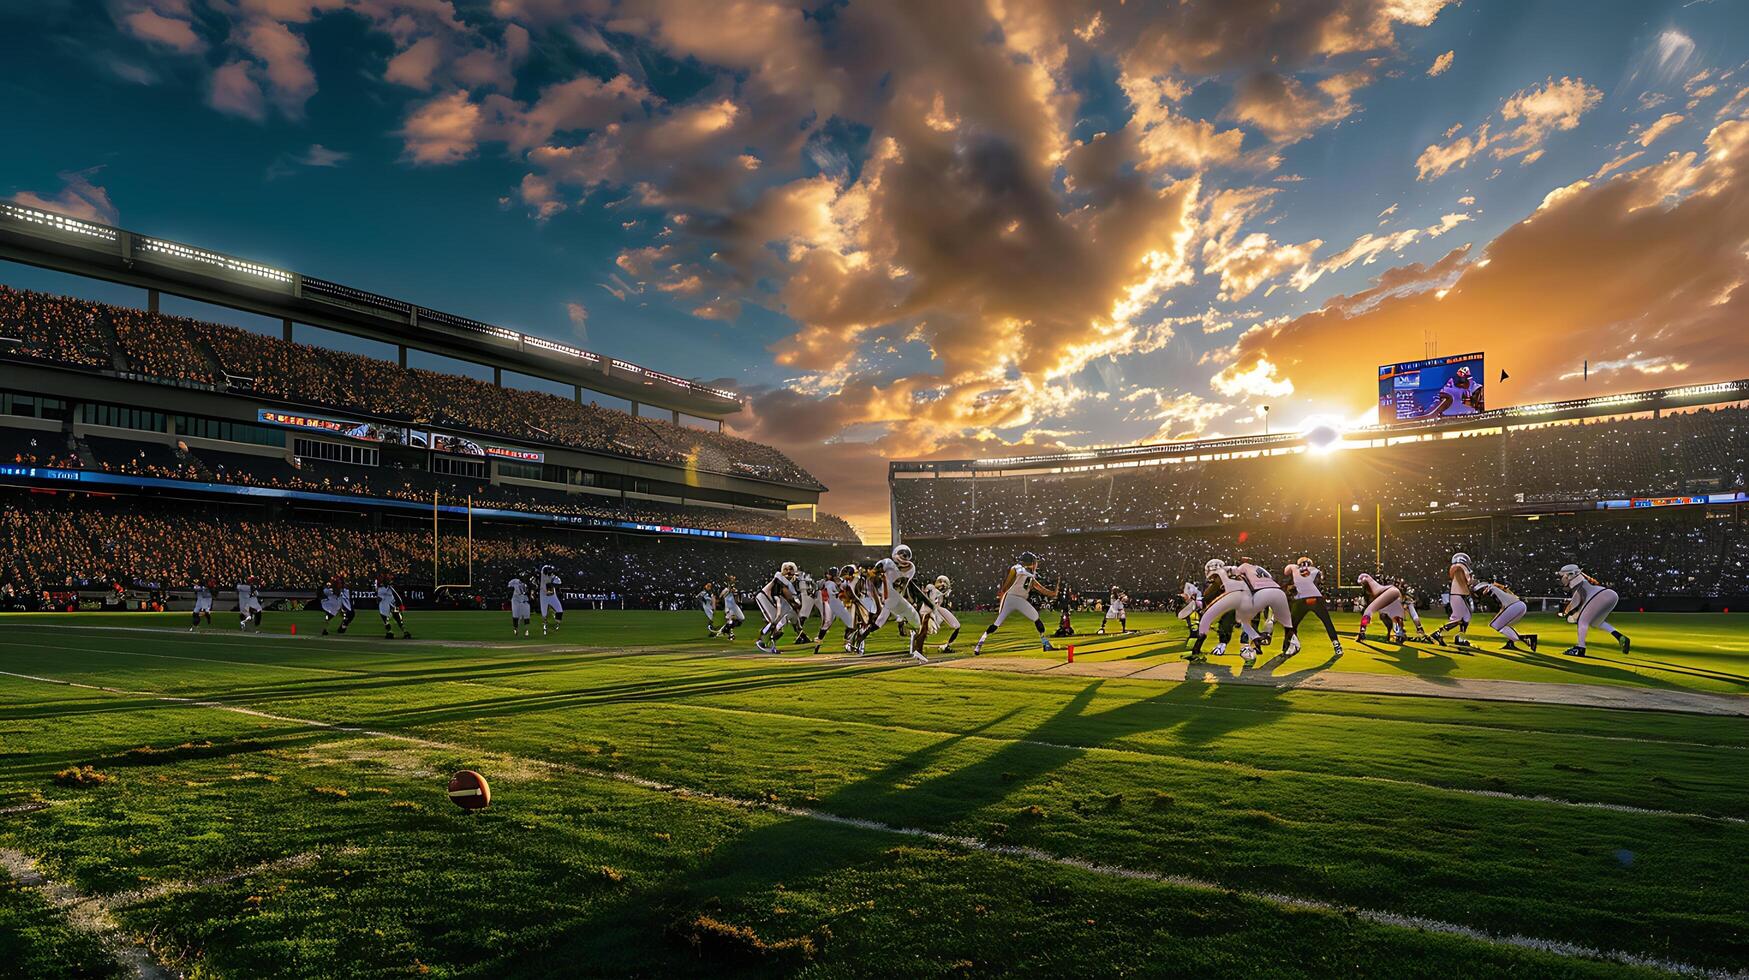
[{"left": 0, "top": 285, "right": 820, "bottom": 487}]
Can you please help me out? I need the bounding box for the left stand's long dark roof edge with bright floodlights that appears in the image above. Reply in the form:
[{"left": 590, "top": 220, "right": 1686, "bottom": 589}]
[{"left": 0, "top": 201, "right": 742, "bottom": 420}]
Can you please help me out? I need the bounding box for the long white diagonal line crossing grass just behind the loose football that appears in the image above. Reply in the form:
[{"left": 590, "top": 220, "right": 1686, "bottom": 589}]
[{"left": 0, "top": 670, "right": 1749, "bottom": 980}]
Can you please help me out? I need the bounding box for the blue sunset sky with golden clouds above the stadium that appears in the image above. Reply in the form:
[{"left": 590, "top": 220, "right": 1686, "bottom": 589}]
[{"left": 0, "top": 0, "right": 1749, "bottom": 541}]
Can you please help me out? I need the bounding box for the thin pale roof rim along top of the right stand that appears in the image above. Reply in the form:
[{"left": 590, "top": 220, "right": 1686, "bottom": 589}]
[{"left": 887, "top": 380, "right": 1749, "bottom": 476}]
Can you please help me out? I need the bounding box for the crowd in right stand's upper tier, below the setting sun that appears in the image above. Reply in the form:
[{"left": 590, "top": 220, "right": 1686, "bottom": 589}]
[{"left": 894, "top": 406, "right": 1749, "bottom": 537}]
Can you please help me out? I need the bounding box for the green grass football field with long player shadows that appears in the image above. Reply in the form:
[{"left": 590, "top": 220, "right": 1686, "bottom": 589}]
[{"left": 0, "top": 609, "right": 1749, "bottom": 978}]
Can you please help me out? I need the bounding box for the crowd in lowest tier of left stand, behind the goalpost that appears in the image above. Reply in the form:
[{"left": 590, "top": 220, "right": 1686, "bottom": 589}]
[{"left": 0, "top": 494, "right": 850, "bottom": 609}]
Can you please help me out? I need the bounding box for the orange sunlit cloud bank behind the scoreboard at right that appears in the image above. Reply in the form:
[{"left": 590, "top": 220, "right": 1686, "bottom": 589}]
[{"left": 1217, "top": 121, "right": 1749, "bottom": 421}]
